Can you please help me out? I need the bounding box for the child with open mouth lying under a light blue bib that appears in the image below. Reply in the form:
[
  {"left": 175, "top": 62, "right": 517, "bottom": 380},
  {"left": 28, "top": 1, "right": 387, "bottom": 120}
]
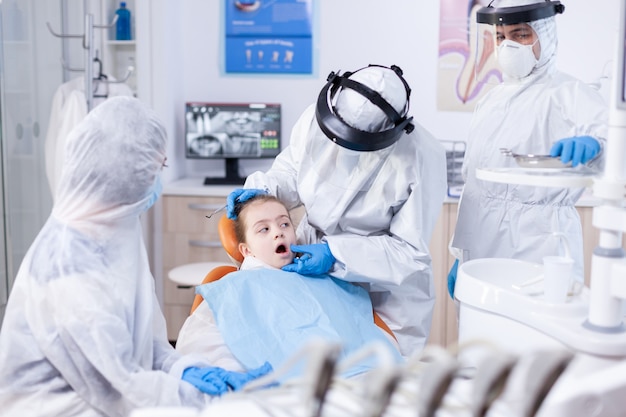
[{"left": 176, "top": 195, "right": 402, "bottom": 376}]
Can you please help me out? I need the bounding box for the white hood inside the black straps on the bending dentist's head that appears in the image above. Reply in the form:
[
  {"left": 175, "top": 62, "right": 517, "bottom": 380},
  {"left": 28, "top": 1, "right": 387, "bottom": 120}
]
[{"left": 335, "top": 66, "right": 407, "bottom": 132}]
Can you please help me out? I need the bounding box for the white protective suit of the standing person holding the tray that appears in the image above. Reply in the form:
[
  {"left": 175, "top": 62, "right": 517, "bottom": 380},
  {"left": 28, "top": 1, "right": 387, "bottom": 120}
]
[{"left": 451, "top": 0, "right": 608, "bottom": 280}]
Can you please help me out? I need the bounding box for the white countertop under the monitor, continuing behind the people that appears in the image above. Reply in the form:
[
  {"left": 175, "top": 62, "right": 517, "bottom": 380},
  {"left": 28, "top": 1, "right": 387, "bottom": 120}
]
[{"left": 163, "top": 177, "right": 601, "bottom": 207}]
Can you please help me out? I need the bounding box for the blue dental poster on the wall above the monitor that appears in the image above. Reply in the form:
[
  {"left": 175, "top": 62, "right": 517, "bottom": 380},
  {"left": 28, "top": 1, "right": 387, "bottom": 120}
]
[{"left": 224, "top": 0, "right": 313, "bottom": 74}]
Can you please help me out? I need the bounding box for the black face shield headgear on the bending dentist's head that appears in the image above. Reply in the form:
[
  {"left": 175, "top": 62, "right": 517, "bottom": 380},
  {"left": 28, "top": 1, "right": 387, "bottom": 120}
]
[{"left": 315, "top": 65, "right": 415, "bottom": 152}]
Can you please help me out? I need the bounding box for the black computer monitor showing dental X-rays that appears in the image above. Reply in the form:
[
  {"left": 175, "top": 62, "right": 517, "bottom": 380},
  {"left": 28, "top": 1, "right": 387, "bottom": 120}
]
[{"left": 185, "top": 102, "right": 281, "bottom": 185}]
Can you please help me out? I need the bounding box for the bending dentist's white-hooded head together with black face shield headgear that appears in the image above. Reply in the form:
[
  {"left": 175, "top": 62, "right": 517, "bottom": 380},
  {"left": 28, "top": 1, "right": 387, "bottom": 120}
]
[{"left": 315, "top": 65, "right": 414, "bottom": 152}]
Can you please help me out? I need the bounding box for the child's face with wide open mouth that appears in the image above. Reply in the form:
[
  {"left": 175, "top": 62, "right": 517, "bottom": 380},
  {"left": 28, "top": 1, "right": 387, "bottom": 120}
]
[{"left": 239, "top": 201, "right": 296, "bottom": 269}]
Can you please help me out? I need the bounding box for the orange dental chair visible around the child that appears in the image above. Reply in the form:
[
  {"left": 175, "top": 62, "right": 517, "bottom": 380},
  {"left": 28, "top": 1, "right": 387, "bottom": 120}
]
[{"left": 190, "top": 214, "right": 397, "bottom": 341}]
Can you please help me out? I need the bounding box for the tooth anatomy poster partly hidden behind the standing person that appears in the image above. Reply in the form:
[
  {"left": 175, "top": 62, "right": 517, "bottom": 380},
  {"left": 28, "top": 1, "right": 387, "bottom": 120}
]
[{"left": 437, "top": 0, "right": 501, "bottom": 111}]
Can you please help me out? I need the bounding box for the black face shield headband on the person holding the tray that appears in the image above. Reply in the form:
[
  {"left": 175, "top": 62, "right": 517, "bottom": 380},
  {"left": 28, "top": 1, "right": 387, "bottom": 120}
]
[{"left": 476, "top": 0, "right": 565, "bottom": 25}]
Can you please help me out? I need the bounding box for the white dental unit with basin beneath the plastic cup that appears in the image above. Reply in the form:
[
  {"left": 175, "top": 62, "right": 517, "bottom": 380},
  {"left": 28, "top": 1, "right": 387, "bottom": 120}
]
[{"left": 454, "top": 258, "right": 626, "bottom": 357}]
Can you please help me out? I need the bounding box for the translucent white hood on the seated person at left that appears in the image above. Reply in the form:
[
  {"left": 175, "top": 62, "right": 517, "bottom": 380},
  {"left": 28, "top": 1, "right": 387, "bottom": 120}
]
[{"left": 54, "top": 97, "right": 166, "bottom": 220}]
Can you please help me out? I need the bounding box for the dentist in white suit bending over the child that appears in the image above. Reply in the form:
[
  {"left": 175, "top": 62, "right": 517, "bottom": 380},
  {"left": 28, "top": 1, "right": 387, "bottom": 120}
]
[{"left": 228, "top": 65, "right": 447, "bottom": 357}]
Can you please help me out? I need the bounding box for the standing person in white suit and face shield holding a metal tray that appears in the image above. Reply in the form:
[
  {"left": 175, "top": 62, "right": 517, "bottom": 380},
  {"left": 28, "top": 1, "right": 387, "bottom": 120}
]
[{"left": 448, "top": 0, "right": 608, "bottom": 296}]
